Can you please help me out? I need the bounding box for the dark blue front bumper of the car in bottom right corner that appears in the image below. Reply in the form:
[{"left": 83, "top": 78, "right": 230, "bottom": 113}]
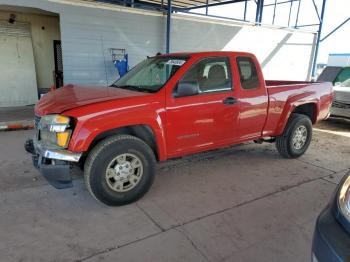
[{"left": 312, "top": 205, "right": 350, "bottom": 262}]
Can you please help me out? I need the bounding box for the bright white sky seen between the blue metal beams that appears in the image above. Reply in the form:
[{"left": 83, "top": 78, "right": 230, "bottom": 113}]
[{"left": 191, "top": 0, "right": 350, "bottom": 63}]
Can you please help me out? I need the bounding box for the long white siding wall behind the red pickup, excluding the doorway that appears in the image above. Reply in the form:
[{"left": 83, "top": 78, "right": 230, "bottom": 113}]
[{"left": 0, "top": 0, "right": 315, "bottom": 85}]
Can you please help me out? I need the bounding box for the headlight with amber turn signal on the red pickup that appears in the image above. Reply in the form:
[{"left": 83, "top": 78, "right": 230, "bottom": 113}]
[{"left": 39, "top": 115, "right": 72, "bottom": 148}]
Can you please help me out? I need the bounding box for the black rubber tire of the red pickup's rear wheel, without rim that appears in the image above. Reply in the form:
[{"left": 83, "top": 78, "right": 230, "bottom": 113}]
[{"left": 276, "top": 113, "right": 312, "bottom": 158}]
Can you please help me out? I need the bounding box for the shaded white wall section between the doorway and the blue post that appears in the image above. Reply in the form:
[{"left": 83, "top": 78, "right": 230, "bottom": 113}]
[{"left": 61, "top": 7, "right": 164, "bottom": 85}]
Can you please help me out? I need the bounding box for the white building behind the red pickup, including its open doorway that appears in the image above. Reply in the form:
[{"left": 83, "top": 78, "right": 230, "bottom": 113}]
[{"left": 0, "top": 0, "right": 316, "bottom": 107}]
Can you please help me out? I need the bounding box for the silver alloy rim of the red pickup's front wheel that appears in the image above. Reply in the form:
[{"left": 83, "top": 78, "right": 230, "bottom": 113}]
[{"left": 105, "top": 153, "right": 143, "bottom": 193}]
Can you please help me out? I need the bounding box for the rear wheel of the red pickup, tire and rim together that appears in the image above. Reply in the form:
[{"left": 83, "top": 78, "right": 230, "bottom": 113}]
[{"left": 276, "top": 113, "right": 312, "bottom": 158}]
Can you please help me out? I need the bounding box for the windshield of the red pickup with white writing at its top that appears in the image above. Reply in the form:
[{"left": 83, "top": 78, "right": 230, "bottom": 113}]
[{"left": 111, "top": 56, "right": 188, "bottom": 93}]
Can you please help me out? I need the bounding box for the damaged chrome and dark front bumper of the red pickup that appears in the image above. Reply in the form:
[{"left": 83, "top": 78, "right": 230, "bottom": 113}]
[{"left": 24, "top": 139, "right": 81, "bottom": 189}]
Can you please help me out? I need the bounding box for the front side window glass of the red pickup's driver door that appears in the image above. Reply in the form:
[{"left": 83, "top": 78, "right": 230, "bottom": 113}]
[{"left": 180, "top": 57, "right": 232, "bottom": 93}]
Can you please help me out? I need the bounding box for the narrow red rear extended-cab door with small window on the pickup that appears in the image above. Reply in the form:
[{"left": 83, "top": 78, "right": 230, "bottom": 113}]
[{"left": 236, "top": 55, "right": 268, "bottom": 141}]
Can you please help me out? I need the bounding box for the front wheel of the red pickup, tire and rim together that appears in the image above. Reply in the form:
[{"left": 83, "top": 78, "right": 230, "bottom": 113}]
[{"left": 84, "top": 135, "right": 156, "bottom": 206}]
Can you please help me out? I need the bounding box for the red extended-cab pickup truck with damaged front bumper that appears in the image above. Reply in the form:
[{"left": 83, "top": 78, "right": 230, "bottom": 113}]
[{"left": 25, "top": 52, "right": 333, "bottom": 205}]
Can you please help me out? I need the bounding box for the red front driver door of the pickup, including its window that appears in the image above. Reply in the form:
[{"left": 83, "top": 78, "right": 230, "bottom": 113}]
[{"left": 166, "top": 56, "right": 239, "bottom": 157}]
